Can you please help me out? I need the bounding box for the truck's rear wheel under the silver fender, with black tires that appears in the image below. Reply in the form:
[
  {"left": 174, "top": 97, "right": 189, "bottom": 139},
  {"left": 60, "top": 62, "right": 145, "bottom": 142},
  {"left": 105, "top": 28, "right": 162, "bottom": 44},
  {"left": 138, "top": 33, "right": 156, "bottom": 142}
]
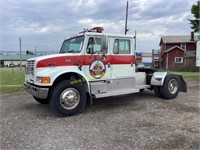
[{"left": 160, "top": 74, "right": 180, "bottom": 99}]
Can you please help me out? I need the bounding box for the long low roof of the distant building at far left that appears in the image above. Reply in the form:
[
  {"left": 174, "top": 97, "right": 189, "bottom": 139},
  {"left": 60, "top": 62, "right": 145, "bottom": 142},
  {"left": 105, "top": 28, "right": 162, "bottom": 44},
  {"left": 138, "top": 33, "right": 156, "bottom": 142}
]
[{"left": 0, "top": 54, "right": 35, "bottom": 61}]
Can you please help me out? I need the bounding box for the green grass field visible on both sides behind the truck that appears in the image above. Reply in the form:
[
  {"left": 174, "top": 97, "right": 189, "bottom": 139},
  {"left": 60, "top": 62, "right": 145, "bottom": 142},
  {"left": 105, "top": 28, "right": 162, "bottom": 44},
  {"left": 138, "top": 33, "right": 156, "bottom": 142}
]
[{"left": 0, "top": 68, "right": 200, "bottom": 93}]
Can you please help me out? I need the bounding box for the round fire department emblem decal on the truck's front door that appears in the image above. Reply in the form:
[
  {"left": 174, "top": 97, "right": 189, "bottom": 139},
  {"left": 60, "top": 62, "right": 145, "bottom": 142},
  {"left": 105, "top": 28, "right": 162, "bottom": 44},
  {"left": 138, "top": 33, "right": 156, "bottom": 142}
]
[{"left": 89, "top": 60, "right": 106, "bottom": 79}]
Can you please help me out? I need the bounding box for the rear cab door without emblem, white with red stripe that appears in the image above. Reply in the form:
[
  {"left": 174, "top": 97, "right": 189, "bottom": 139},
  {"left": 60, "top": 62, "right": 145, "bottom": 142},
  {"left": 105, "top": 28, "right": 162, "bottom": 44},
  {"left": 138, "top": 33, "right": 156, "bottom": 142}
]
[{"left": 109, "top": 37, "right": 135, "bottom": 79}]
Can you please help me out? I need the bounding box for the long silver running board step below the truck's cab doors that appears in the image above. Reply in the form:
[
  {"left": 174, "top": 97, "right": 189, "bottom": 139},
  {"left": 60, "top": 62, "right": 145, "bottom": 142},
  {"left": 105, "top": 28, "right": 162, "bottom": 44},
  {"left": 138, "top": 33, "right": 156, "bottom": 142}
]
[{"left": 94, "top": 88, "right": 139, "bottom": 98}]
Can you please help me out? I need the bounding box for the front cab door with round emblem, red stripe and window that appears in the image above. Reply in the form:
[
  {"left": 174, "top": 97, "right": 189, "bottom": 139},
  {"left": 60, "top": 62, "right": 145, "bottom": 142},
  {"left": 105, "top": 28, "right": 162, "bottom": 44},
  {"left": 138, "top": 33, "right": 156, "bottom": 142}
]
[{"left": 84, "top": 36, "right": 111, "bottom": 81}]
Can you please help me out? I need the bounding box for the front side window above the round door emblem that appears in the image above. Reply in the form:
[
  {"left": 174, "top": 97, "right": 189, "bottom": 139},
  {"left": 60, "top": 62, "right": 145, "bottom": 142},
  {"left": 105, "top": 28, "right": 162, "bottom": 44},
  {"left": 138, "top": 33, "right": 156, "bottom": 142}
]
[{"left": 87, "top": 37, "right": 101, "bottom": 54}]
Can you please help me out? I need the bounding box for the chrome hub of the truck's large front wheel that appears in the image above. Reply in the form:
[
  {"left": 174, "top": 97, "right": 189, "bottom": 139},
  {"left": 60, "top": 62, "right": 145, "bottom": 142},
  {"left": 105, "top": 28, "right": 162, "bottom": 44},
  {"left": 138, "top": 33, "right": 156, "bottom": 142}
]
[{"left": 60, "top": 88, "right": 80, "bottom": 110}]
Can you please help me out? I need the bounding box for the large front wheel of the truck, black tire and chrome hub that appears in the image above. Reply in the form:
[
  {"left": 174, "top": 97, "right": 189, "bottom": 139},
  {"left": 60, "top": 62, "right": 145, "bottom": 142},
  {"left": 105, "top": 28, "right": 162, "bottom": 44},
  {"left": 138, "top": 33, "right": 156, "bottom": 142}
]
[{"left": 49, "top": 80, "right": 86, "bottom": 117}]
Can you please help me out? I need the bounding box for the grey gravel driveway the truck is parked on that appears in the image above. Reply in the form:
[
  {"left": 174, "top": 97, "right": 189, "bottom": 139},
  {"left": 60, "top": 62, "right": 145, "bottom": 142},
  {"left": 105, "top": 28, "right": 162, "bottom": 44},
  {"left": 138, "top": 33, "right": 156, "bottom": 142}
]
[{"left": 0, "top": 80, "right": 200, "bottom": 150}]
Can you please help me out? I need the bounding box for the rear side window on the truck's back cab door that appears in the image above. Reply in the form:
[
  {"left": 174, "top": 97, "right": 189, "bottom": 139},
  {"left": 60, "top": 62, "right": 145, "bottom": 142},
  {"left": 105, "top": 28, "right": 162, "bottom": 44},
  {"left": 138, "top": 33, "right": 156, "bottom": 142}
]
[{"left": 113, "top": 39, "right": 130, "bottom": 54}]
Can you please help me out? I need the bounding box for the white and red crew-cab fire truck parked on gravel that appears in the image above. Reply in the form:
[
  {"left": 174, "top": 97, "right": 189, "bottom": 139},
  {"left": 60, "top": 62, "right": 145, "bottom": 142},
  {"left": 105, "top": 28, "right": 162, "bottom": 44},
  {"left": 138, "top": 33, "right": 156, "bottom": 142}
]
[{"left": 24, "top": 27, "right": 187, "bottom": 116}]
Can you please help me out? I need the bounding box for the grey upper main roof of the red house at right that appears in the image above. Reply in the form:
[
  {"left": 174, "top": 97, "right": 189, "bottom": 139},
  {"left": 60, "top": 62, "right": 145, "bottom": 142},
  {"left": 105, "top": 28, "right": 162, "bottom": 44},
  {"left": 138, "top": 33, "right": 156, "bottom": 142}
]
[{"left": 159, "top": 35, "right": 198, "bottom": 45}]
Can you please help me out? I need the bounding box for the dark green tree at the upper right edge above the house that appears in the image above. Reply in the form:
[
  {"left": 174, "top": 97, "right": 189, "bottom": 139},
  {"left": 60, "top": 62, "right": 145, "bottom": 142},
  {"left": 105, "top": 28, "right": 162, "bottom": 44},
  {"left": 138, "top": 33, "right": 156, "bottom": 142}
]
[{"left": 189, "top": 0, "right": 200, "bottom": 32}]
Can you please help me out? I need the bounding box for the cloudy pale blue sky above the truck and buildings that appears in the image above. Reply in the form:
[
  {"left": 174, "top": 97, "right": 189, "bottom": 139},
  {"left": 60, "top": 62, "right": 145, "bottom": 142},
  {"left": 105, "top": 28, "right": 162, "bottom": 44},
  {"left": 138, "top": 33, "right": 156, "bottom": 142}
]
[{"left": 0, "top": 0, "right": 197, "bottom": 52}]
